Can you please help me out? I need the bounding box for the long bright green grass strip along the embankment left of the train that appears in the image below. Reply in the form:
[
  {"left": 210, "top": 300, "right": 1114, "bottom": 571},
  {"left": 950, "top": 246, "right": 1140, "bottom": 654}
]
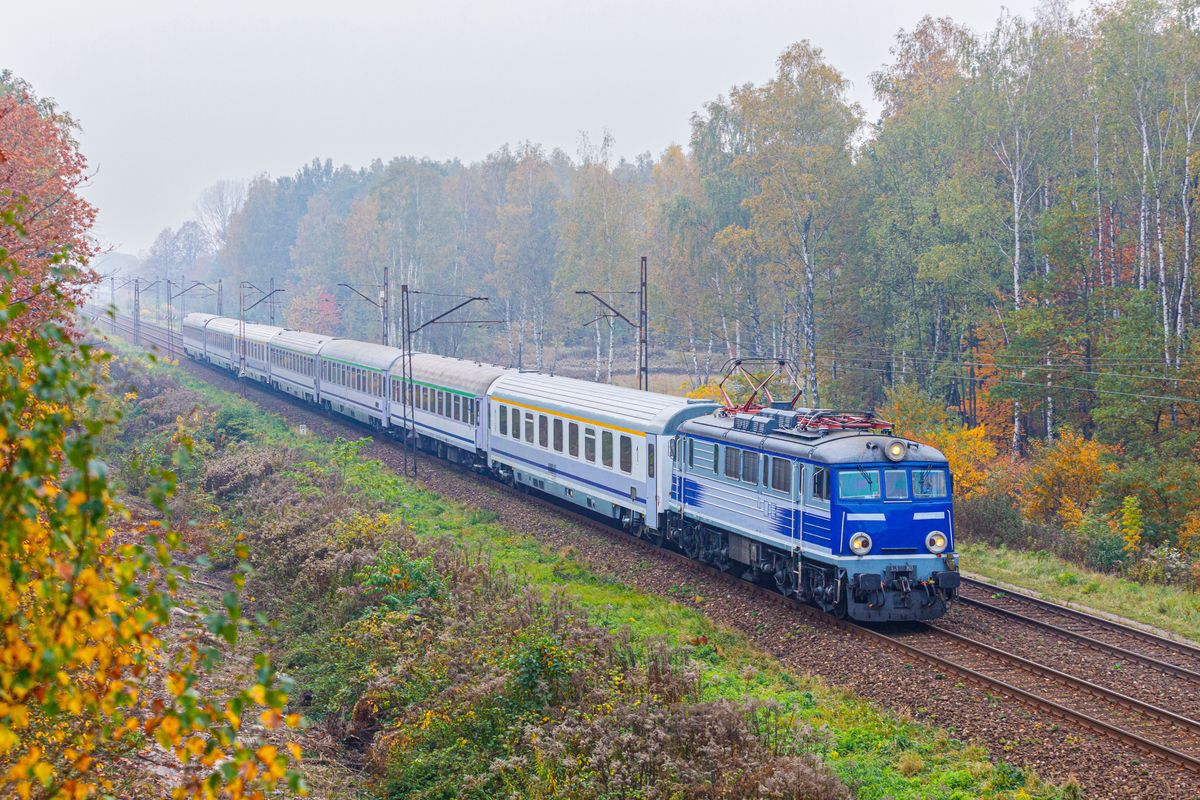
[{"left": 152, "top": 359, "right": 1080, "bottom": 800}]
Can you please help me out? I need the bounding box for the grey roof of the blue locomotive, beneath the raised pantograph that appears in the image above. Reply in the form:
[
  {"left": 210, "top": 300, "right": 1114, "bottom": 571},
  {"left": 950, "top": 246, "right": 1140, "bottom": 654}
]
[{"left": 679, "top": 414, "right": 946, "bottom": 464}]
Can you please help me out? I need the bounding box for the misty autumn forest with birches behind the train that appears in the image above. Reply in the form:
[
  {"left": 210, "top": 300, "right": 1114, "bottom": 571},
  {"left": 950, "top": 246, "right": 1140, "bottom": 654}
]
[{"left": 129, "top": 0, "right": 1200, "bottom": 575}]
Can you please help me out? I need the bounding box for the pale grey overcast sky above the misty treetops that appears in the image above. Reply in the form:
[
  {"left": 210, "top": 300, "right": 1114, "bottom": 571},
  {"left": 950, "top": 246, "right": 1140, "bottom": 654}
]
[{"left": 0, "top": 0, "right": 1051, "bottom": 252}]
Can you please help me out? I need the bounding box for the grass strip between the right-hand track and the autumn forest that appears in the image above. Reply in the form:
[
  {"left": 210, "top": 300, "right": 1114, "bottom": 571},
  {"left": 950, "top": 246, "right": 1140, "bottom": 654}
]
[{"left": 959, "top": 545, "right": 1200, "bottom": 642}]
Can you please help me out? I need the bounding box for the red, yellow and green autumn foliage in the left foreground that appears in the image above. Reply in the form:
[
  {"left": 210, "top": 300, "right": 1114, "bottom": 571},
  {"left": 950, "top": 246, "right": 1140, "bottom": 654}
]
[{"left": 0, "top": 76, "right": 300, "bottom": 799}]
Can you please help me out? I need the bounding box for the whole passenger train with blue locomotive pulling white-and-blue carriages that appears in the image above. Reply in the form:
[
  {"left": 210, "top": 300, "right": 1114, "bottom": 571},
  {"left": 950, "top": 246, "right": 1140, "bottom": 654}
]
[{"left": 182, "top": 313, "right": 960, "bottom": 622}]
